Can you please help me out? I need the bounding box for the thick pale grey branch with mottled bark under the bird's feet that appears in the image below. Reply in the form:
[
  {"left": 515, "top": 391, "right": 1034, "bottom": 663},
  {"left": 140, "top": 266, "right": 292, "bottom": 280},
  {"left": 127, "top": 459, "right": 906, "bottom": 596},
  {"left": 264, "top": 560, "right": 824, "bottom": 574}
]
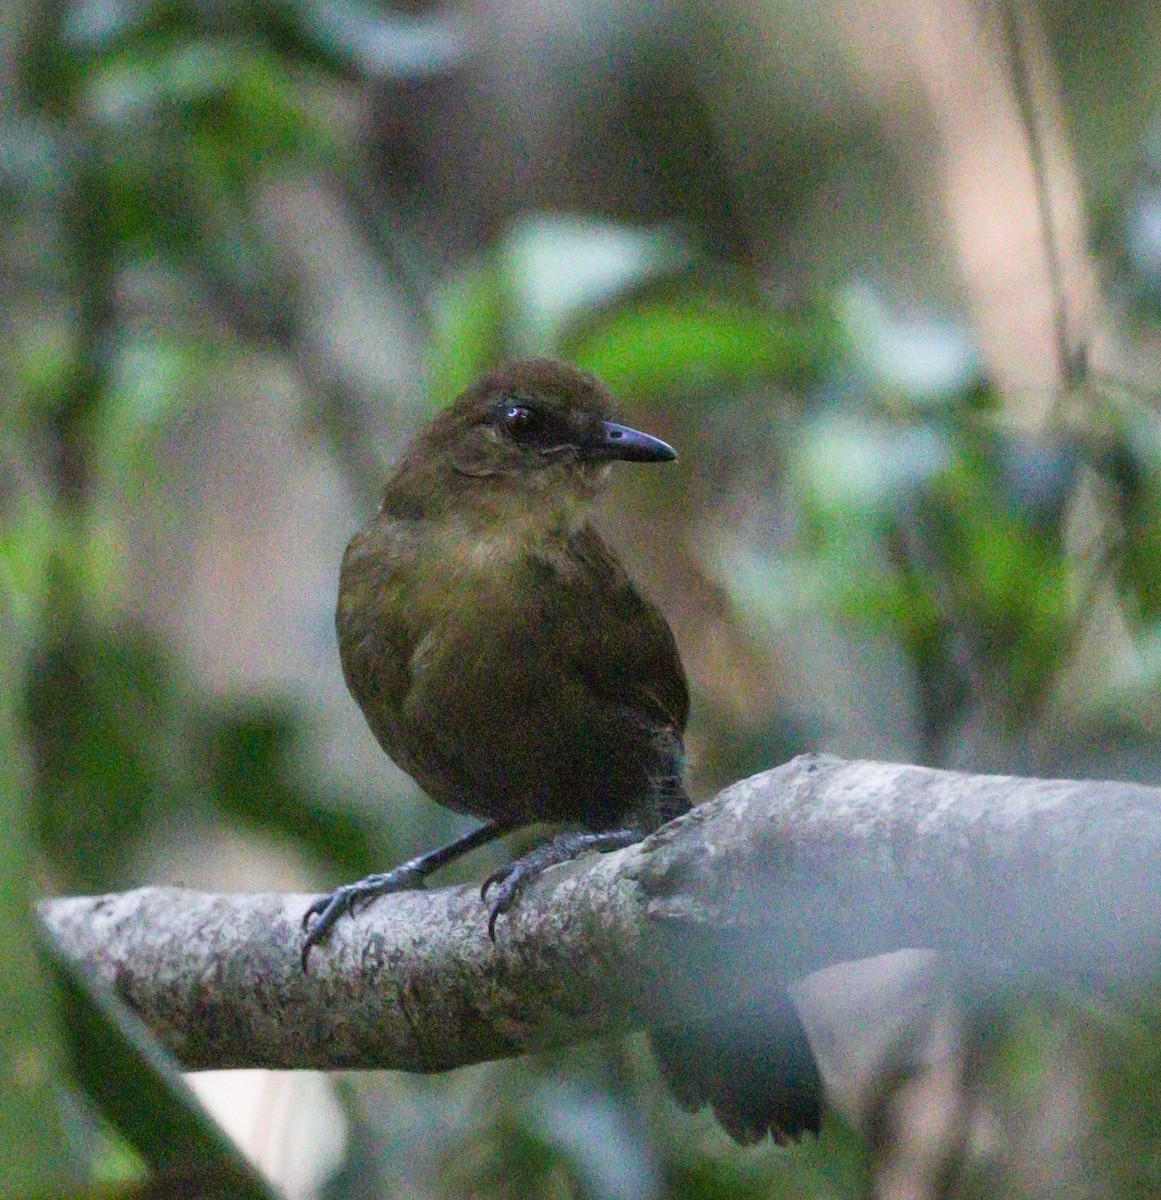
[{"left": 42, "top": 756, "right": 1161, "bottom": 1072}]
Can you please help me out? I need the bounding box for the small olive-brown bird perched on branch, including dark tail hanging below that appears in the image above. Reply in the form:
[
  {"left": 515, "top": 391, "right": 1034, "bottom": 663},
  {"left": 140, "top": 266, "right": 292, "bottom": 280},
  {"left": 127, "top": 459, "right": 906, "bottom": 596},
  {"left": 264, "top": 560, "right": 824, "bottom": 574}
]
[{"left": 302, "top": 359, "right": 820, "bottom": 1141}]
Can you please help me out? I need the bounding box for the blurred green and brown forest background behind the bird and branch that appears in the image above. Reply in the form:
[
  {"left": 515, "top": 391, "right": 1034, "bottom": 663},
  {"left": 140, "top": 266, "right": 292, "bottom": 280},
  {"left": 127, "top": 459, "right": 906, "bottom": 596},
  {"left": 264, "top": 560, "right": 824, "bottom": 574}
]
[{"left": 0, "top": 0, "right": 1161, "bottom": 1200}]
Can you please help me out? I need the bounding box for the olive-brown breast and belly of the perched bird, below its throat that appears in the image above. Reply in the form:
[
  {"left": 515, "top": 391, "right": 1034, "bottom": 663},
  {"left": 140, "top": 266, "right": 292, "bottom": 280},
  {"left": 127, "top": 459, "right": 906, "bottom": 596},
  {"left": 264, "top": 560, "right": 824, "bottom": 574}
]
[{"left": 339, "top": 511, "right": 680, "bottom": 828}]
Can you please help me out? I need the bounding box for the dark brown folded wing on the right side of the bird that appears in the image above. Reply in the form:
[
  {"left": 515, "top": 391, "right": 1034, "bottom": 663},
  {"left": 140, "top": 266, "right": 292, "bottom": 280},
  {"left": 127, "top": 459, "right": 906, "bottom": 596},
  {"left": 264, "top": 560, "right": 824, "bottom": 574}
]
[{"left": 560, "top": 526, "right": 690, "bottom": 737}]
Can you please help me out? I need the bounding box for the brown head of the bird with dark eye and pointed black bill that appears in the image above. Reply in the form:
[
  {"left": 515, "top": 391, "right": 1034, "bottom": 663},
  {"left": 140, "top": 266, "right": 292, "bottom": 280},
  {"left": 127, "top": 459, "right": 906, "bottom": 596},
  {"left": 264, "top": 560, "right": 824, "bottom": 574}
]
[{"left": 386, "top": 359, "right": 676, "bottom": 525}]
